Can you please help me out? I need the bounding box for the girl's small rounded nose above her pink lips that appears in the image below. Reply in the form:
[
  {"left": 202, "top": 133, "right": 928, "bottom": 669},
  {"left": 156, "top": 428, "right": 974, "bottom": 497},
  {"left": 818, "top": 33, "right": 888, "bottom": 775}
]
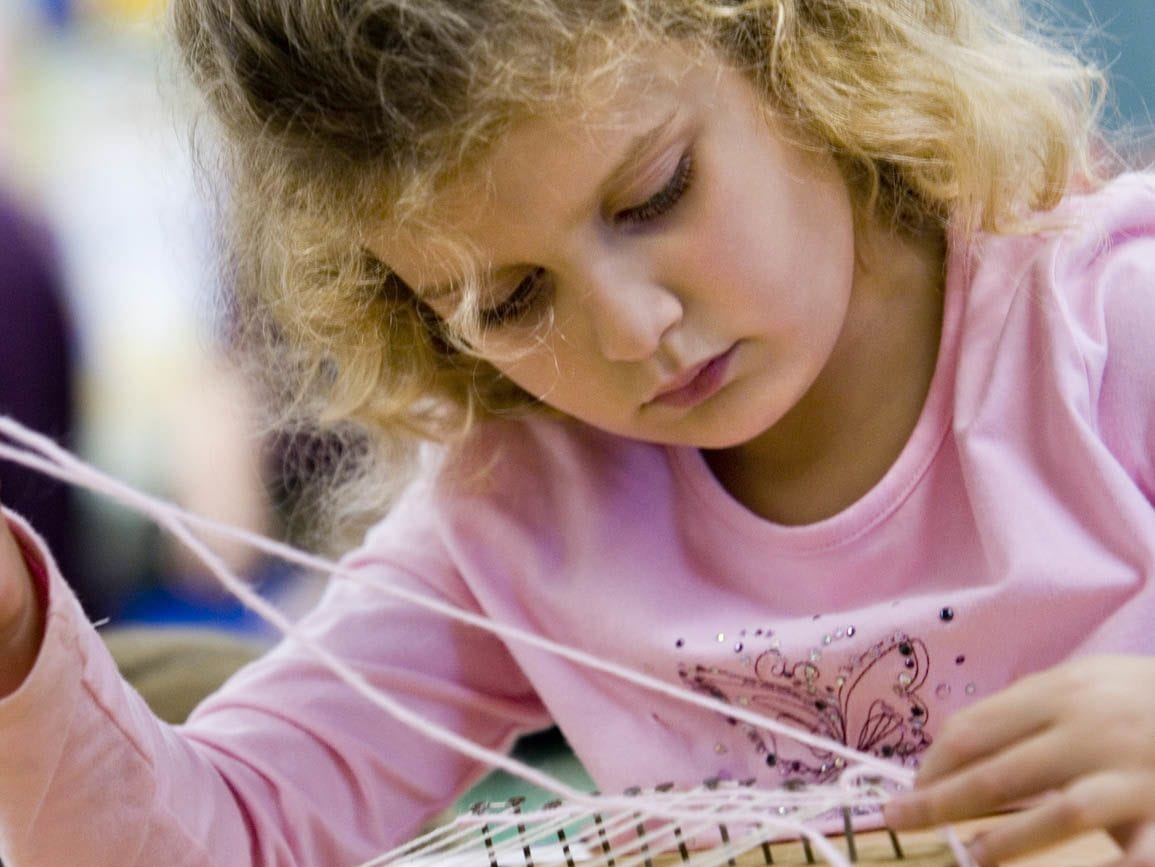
[{"left": 582, "top": 261, "right": 683, "bottom": 361}]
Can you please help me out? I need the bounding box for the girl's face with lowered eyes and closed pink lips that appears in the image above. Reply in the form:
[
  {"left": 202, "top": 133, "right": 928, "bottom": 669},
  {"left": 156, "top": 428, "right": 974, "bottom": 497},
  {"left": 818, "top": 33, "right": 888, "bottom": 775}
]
[{"left": 373, "top": 50, "right": 855, "bottom": 448}]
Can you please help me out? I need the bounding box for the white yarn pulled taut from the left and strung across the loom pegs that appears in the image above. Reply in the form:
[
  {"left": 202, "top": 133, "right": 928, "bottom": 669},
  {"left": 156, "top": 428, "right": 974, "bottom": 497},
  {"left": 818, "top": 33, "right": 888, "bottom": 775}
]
[{"left": 0, "top": 416, "right": 966, "bottom": 867}]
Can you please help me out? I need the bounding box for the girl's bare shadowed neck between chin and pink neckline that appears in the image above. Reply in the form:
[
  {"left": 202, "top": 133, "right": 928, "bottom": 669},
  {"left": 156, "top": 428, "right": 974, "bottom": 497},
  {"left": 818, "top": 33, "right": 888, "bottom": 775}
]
[{"left": 705, "top": 224, "right": 946, "bottom": 524}]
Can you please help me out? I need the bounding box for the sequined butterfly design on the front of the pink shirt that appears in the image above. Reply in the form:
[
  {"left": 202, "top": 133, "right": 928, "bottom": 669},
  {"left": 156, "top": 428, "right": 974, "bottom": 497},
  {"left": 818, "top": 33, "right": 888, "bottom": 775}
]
[{"left": 678, "top": 634, "right": 931, "bottom": 783}]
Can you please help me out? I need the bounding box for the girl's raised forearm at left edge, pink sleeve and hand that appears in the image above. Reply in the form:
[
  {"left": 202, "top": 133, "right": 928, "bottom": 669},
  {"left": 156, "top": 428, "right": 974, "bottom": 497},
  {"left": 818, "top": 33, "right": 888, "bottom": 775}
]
[{"left": 0, "top": 511, "right": 250, "bottom": 867}]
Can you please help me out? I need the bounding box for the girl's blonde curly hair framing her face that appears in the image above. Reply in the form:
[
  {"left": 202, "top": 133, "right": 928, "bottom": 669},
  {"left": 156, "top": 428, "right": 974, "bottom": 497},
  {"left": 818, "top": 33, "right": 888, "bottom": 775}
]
[{"left": 173, "top": 0, "right": 1102, "bottom": 542}]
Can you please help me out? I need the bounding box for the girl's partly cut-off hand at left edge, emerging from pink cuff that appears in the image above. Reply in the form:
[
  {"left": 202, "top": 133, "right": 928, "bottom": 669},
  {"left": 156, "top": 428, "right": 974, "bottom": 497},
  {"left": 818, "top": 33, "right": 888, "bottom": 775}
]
[{"left": 0, "top": 507, "right": 44, "bottom": 698}]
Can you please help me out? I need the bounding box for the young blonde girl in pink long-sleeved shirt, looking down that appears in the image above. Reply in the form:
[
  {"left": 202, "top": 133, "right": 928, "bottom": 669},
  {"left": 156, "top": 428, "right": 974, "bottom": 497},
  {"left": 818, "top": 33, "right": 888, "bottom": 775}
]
[{"left": 0, "top": 0, "right": 1155, "bottom": 867}]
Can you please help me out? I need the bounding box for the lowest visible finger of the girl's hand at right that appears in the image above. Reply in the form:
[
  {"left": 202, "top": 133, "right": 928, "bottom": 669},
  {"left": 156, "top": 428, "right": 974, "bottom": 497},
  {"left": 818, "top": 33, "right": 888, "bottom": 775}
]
[{"left": 968, "top": 771, "right": 1155, "bottom": 865}]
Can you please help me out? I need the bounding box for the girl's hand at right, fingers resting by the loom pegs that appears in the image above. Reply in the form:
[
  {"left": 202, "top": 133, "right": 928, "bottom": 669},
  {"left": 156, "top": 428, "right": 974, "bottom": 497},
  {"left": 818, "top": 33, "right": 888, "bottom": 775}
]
[{"left": 885, "top": 657, "right": 1155, "bottom": 866}]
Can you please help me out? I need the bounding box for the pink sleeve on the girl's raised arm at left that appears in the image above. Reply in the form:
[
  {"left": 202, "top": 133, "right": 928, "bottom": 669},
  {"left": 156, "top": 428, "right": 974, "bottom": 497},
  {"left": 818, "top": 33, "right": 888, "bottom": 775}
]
[{"left": 0, "top": 505, "right": 549, "bottom": 867}]
